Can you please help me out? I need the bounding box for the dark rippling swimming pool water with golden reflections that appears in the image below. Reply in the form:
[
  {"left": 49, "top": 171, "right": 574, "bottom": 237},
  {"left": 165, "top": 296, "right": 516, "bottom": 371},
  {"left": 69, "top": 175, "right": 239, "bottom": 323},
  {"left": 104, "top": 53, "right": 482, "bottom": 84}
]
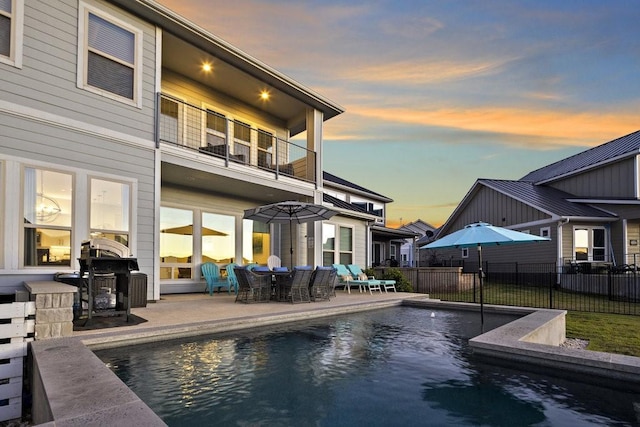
[{"left": 96, "top": 307, "right": 640, "bottom": 427}]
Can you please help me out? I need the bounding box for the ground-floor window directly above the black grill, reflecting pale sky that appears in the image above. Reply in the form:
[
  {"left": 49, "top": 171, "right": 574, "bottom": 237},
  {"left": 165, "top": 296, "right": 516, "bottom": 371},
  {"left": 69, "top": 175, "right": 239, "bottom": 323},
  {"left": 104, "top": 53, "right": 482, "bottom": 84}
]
[{"left": 90, "top": 178, "right": 131, "bottom": 246}]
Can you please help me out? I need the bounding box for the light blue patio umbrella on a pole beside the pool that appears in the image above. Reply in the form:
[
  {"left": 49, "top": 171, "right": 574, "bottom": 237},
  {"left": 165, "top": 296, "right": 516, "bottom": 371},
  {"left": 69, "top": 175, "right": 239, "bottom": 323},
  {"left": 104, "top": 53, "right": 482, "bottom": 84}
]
[{"left": 420, "top": 222, "right": 549, "bottom": 325}]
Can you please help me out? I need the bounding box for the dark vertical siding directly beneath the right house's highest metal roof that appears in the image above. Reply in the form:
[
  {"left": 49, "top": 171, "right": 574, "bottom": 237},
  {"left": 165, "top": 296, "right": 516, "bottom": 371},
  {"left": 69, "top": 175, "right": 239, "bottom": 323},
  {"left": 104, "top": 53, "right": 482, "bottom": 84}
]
[{"left": 548, "top": 157, "right": 636, "bottom": 198}]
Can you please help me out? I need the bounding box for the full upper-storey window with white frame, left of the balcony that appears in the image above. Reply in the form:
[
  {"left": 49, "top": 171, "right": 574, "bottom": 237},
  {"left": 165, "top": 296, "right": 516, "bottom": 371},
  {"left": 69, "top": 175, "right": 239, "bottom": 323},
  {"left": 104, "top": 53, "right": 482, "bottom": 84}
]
[{"left": 78, "top": 4, "right": 142, "bottom": 107}]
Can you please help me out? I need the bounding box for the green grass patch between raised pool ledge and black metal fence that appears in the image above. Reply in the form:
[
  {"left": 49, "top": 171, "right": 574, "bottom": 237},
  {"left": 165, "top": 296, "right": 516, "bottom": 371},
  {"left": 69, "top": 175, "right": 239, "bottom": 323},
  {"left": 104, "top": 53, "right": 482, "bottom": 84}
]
[{"left": 567, "top": 311, "right": 640, "bottom": 357}]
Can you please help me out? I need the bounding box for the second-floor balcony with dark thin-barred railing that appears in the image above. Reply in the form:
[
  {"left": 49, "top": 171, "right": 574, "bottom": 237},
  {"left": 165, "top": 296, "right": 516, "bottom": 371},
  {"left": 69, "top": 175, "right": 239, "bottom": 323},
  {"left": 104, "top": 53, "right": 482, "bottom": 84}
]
[{"left": 156, "top": 94, "right": 316, "bottom": 182}]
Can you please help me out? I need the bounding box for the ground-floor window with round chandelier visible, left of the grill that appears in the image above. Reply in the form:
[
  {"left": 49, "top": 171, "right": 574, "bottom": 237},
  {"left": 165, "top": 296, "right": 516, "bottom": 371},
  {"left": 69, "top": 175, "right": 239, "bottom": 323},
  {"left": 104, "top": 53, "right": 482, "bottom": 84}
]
[{"left": 23, "top": 167, "right": 73, "bottom": 267}]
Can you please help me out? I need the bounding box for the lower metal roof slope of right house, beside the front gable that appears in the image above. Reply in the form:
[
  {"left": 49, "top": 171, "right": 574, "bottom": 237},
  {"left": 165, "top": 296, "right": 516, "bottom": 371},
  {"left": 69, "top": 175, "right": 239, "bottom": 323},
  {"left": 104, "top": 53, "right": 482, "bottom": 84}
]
[{"left": 478, "top": 179, "right": 615, "bottom": 219}]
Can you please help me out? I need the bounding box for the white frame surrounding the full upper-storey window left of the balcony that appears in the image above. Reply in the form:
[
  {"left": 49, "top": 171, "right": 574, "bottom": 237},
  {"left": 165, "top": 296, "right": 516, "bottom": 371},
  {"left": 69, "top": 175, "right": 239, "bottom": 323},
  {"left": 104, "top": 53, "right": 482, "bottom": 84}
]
[{"left": 76, "top": 1, "right": 143, "bottom": 108}]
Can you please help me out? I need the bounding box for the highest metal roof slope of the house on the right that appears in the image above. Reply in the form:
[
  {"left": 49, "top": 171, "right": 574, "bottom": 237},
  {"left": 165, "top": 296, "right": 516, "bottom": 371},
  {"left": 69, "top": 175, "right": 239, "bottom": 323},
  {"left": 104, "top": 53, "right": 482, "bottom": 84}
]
[{"left": 521, "top": 131, "right": 640, "bottom": 183}]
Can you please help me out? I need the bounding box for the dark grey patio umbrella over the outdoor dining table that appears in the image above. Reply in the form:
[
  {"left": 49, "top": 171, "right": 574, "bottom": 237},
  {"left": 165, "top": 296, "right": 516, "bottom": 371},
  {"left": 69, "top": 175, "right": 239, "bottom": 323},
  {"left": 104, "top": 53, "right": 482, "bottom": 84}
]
[{"left": 244, "top": 201, "right": 338, "bottom": 267}]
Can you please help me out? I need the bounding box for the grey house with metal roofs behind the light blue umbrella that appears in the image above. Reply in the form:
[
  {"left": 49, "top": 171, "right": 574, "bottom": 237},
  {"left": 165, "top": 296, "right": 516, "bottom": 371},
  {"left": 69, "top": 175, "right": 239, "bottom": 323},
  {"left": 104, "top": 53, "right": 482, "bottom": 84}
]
[{"left": 430, "top": 131, "right": 640, "bottom": 268}]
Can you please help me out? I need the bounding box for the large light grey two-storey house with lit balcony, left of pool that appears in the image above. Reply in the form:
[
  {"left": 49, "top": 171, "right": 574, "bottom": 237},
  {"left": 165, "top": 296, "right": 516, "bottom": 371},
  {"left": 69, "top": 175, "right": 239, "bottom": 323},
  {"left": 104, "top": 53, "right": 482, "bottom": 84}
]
[{"left": 0, "top": 0, "right": 378, "bottom": 300}]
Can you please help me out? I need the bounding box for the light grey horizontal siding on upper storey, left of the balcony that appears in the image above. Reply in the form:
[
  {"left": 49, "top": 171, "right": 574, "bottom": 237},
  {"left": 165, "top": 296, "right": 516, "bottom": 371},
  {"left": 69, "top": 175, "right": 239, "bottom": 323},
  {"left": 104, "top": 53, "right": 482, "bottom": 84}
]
[{"left": 0, "top": 0, "right": 155, "bottom": 140}]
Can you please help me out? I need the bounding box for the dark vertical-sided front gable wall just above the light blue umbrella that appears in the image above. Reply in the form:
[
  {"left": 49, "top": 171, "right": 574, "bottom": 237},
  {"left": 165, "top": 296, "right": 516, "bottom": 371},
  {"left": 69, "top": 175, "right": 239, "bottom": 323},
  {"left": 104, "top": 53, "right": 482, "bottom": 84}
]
[{"left": 440, "top": 186, "right": 551, "bottom": 237}]
